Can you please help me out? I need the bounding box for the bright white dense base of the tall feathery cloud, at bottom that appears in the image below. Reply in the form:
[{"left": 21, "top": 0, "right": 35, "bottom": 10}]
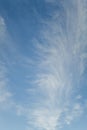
[{"left": 33, "top": 108, "right": 61, "bottom": 130}]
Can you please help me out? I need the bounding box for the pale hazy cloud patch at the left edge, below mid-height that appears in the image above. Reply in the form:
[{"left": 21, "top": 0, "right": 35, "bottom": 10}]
[{"left": 0, "top": 63, "right": 12, "bottom": 109}]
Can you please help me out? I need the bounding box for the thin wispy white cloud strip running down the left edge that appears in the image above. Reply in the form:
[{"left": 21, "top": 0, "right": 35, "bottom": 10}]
[{"left": 0, "top": 16, "right": 12, "bottom": 109}]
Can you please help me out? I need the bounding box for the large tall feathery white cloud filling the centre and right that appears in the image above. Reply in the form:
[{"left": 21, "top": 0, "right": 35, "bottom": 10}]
[{"left": 27, "top": 0, "right": 87, "bottom": 130}]
